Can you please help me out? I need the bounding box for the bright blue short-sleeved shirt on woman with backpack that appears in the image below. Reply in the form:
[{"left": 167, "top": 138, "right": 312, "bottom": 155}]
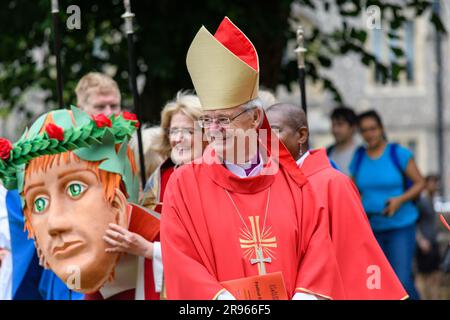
[{"left": 350, "top": 144, "right": 419, "bottom": 231}]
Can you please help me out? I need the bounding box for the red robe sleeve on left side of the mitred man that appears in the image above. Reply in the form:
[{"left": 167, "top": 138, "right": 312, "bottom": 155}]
[{"left": 161, "top": 177, "right": 224, "bottom": 300}]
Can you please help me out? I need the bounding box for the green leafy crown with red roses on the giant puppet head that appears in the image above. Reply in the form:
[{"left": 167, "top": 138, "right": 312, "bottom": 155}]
[{"left": 0, "top": 106, "right": 139, "bottom": 200}]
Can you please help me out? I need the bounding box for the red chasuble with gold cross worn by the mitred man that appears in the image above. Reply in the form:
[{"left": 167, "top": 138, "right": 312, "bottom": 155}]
[{"left": 161, "top": 115, "right": 343, "bottom": 299}]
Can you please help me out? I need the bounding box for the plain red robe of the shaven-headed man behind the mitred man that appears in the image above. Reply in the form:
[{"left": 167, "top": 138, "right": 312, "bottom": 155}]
[{"left": 301, "top": 149, "right": 407, "bottom": 300}]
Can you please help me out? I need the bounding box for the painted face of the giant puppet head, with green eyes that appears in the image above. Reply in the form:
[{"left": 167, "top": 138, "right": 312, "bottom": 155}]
[{"left": 24, "top": 156, "right": 127, "bottom": 293}]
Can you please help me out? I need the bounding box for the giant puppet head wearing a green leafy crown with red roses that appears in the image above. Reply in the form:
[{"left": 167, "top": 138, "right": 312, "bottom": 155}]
[{"left": 0, "top": 107, "right": 158, "bottom": 293}]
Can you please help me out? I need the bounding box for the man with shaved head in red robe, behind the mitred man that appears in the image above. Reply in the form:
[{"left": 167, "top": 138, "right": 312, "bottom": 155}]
[{"left": 266, "top": 103, "right": 407, "bottom": 299}]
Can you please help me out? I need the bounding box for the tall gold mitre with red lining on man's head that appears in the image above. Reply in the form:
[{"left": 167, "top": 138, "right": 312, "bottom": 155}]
[{"left": 186, "top": 17, "right": 259, "bottom": 110}]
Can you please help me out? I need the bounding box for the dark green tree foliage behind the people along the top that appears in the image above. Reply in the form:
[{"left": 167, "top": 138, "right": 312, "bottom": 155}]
[{"left": 0, "top": 0, "right": 445, "bottom": 122}]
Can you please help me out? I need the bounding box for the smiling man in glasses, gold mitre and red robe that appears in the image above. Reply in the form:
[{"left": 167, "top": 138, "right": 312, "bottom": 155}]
[{"left": 161, "top": 18, "right": 343, "bottom": 299}]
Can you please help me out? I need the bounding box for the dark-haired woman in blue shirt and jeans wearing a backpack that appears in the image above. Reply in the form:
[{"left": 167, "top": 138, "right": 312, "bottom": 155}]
[{"left": 350, "top": 110, "right": 425, "bottom": 299}]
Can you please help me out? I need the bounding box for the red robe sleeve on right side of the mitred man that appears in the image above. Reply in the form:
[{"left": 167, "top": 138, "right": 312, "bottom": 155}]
[{"left": 295, "top": 184, "right": 343, "bottom": 299}]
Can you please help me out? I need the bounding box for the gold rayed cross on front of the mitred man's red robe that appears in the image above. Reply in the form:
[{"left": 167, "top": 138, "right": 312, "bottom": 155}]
[{"left": 239, "top": 216, "right": 277, "bottom": 275}]
